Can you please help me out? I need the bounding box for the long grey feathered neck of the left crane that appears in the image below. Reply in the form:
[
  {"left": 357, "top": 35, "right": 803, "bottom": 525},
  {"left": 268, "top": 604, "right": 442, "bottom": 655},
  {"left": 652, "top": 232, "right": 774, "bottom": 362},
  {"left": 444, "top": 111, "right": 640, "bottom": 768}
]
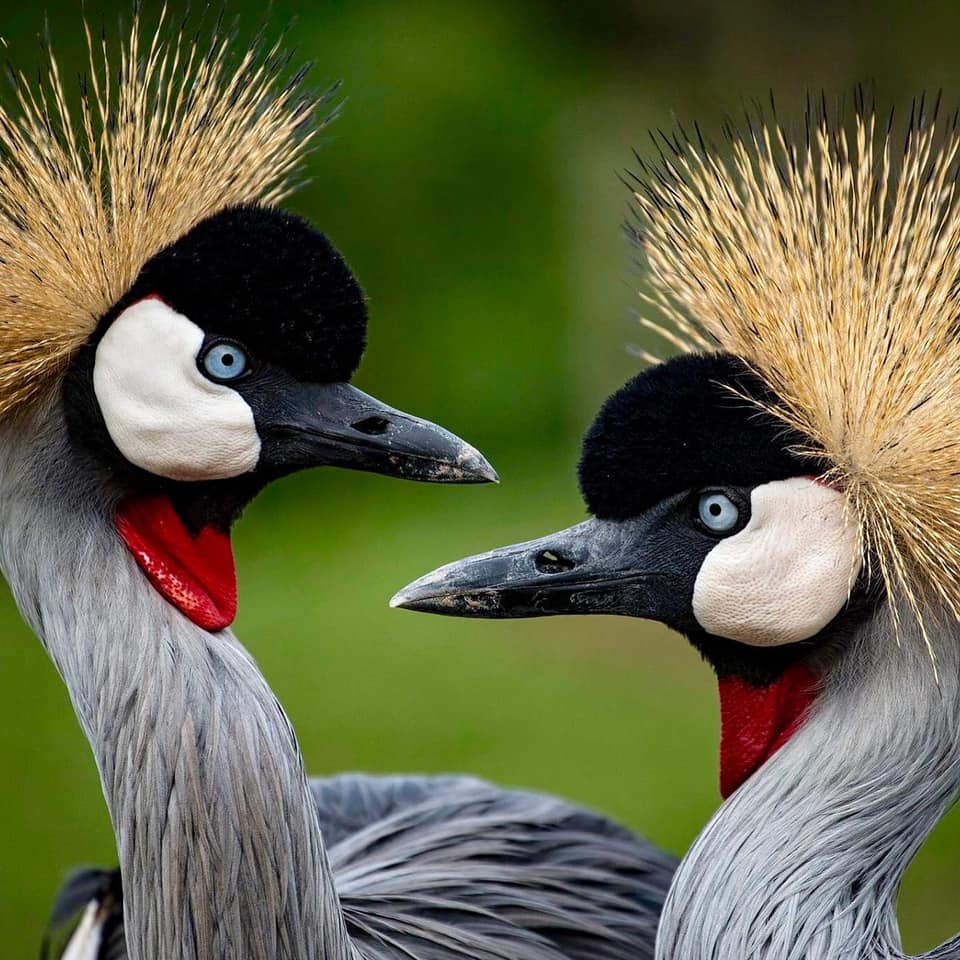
[{"left": 0, "top": 406, "right": 352, "bottom": 960}]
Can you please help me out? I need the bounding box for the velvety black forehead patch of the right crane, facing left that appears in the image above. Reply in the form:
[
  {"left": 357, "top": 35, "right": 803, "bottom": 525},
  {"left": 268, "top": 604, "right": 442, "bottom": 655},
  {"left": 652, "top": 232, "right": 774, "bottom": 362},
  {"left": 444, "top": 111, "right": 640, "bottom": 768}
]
[{"left": 580, "top": 353, "right": 829, "bottom": 519}]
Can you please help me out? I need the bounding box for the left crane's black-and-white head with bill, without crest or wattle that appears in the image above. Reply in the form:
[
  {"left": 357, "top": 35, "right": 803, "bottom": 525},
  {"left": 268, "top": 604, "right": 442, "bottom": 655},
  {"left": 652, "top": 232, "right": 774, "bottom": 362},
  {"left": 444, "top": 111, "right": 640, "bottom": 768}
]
[{"left": 64, "top": 206, "right": 496, "bottom": 506}]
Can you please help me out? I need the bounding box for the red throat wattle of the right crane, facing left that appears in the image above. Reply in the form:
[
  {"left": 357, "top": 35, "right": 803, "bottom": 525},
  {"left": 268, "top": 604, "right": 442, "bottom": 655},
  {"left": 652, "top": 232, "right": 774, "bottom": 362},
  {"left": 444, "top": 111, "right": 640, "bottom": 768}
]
[{"left": 719, "top": 663, "right": 818, "bottom": 799}]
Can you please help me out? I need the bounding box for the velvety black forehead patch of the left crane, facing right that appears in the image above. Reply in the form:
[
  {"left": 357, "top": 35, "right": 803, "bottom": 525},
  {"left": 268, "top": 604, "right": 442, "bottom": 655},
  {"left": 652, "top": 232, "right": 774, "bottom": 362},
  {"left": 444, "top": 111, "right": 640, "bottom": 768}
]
[{"left": 113, "top": 205, "right": 367, "bottom": 382}]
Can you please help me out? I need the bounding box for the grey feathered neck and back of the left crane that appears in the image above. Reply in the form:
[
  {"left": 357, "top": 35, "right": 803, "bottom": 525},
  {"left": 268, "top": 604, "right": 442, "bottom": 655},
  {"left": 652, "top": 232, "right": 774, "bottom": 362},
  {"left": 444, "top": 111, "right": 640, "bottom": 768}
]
[{"left": 0, "top": 401, "right": 672, "bottom": 960}]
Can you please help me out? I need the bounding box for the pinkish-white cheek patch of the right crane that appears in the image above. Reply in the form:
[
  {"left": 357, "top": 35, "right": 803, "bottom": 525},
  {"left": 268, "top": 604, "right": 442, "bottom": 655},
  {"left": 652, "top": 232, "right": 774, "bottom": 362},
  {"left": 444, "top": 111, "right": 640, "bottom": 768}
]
[{"left": 693, "top": 477, "right": 861, "bottom": 647}]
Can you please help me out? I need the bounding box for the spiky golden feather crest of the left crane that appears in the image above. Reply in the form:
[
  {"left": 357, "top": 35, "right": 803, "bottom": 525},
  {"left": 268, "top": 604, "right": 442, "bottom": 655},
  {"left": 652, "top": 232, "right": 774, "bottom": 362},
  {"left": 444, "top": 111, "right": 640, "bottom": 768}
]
[{"left": 0, "top": 11, "right": 324, "bottom": 416}]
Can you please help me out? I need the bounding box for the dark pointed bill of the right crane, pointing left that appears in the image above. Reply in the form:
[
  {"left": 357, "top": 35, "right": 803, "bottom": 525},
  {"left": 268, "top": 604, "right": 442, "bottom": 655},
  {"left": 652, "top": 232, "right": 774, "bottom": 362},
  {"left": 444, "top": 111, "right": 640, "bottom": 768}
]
[{"left": 390, "top": 518, "right": 679, "bottom": 619}]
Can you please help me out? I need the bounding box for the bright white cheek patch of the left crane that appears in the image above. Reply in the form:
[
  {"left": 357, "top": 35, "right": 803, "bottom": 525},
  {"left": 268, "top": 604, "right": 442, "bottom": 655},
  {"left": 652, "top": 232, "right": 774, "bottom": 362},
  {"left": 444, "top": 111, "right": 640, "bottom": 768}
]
[{"left": 93, "top": 298, "right": 260, "bottom": 480}]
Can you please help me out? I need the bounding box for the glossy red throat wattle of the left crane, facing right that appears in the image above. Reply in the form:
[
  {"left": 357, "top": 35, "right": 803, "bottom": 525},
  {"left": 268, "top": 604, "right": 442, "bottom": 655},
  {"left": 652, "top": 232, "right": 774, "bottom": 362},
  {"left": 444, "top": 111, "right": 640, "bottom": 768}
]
[{"left": 116, "top": 496, "right": 237, "bottom": 630}]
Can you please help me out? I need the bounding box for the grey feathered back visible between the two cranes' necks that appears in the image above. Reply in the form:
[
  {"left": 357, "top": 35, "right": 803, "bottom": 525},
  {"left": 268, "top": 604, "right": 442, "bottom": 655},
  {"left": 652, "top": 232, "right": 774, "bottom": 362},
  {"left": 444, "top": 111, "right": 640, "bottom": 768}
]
[{"left": 48, "top": 774, "right": 675, "bottom": 960}]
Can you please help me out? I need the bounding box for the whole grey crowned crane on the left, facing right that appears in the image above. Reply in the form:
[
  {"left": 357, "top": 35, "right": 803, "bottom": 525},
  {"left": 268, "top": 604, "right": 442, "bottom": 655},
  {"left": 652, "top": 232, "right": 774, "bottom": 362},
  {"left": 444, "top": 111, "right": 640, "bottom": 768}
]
[{"left": 0, "top": 18, "right": 673, "bottom": 960}]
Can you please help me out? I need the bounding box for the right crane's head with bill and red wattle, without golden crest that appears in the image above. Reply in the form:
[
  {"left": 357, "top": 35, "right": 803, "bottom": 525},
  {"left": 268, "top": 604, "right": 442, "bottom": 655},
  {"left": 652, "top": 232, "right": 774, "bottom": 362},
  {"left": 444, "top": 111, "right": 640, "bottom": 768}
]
[{"left": 392, "top": 354, "right": 877, "bottom": 793}]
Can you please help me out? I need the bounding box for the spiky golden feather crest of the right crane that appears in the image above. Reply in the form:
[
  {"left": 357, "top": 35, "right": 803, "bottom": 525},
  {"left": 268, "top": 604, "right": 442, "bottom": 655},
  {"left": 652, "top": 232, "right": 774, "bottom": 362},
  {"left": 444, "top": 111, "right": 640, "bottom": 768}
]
[{"left": 634, "top": 104, "right": 960, "bottom": 652}]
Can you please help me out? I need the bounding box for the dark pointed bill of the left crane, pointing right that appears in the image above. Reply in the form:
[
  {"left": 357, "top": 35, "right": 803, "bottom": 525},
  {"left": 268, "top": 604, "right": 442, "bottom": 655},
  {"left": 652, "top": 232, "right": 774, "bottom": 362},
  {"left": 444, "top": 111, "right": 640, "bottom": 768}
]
[{"left": 257, "top": 383, "right": 499, "bottom": 483}]
